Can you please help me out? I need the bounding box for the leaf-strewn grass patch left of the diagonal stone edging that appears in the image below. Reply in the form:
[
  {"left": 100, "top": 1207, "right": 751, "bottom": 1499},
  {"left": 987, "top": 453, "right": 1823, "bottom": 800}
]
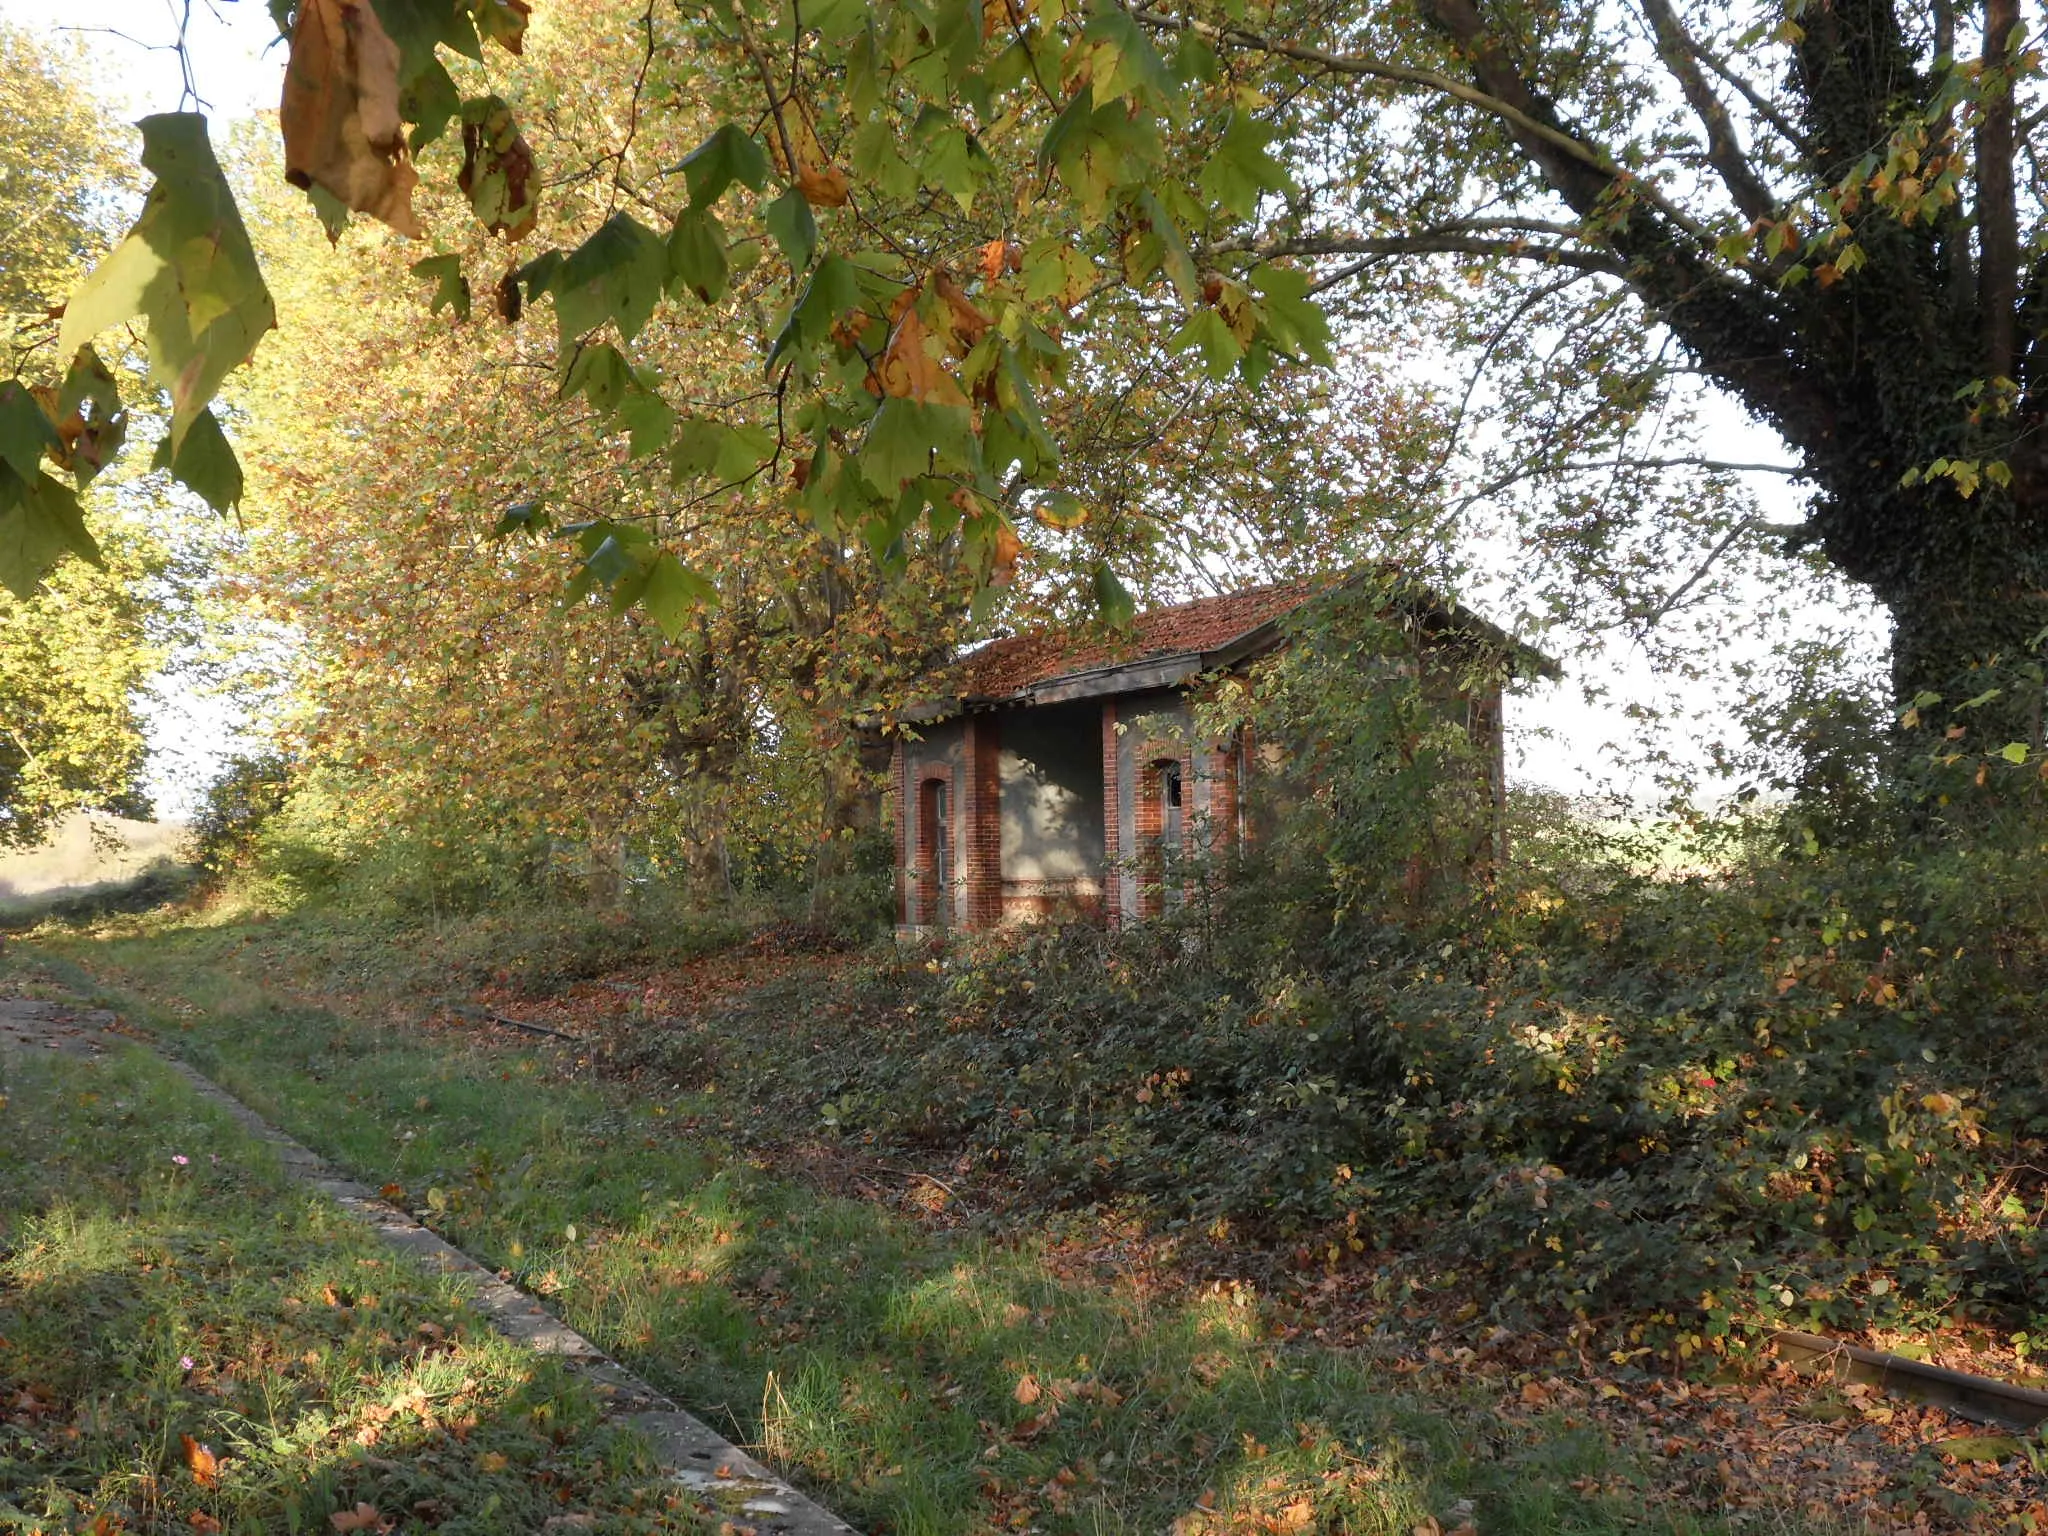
[{"left": 0, "top": 1015, "right": 700, "bottom": 1536}]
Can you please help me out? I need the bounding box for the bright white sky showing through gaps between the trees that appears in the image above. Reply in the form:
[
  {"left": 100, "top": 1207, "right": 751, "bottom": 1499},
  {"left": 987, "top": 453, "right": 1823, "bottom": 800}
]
[{"left": 0, "top": 0, "right": 1886, "bottom": 817}]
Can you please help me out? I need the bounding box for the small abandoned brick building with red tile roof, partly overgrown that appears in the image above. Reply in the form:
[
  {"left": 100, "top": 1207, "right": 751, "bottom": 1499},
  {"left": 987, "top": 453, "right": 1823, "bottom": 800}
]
[{"left": 889, "top": 582, "right": 1554, "bottom": 932}]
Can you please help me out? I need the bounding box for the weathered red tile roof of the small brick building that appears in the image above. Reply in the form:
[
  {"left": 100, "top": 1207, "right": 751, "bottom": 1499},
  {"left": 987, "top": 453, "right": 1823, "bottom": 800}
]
[{"left": 948, "top": 578, "right": 1329, "bottom": 698}]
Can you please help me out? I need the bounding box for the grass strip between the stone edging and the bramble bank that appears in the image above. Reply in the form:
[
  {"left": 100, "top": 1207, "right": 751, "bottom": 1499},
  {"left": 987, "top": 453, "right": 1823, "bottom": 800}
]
[{"left": 14, "top": 922, "right": 1859, "bottom": 1536}]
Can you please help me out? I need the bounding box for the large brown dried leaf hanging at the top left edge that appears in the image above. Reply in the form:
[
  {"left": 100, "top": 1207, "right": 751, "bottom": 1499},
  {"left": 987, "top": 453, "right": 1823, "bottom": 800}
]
[{"left": 279, "top": 0, "right": 420, "bottom": 238}]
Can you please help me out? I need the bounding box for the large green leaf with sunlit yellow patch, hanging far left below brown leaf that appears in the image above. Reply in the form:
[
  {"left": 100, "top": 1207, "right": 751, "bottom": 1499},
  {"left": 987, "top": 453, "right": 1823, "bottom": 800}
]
[{"left": 57, "top": 113, "right": 276, "bottom": 453}]
